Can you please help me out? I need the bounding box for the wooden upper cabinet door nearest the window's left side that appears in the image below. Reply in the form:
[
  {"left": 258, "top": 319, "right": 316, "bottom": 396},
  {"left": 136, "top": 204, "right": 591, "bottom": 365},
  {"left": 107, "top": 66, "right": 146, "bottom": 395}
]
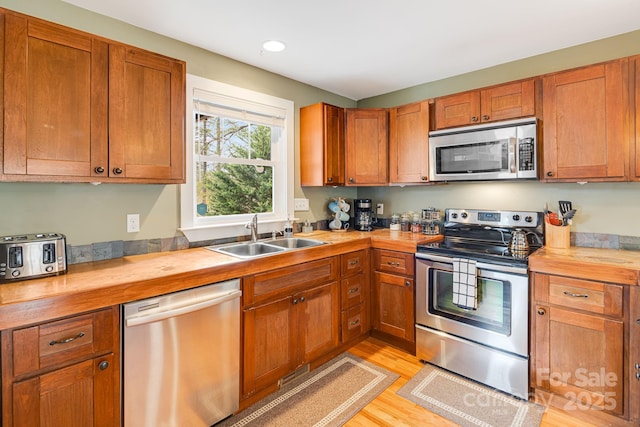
[{"left": 109, "top": 44, "right": 186, "bottom": 183}]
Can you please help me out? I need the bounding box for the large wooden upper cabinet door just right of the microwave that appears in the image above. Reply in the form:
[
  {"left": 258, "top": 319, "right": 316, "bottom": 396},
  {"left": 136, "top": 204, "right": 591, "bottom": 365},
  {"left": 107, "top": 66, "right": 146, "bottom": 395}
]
[{"left": 543, "top": 59, "right": 629, "bottom": 181}]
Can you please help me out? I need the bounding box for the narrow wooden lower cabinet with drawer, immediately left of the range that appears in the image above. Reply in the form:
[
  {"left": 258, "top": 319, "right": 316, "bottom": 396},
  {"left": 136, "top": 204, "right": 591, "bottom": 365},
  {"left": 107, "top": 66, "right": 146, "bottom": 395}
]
[{"left": 372, "top": 249, "right": 416, "bottom": 354}]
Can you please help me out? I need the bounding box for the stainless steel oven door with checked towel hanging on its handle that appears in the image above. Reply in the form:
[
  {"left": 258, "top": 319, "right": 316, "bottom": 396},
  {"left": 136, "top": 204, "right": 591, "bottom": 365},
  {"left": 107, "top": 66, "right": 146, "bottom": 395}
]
[{"left": 416, "top": 253, "right": 529, "bottom": 357}]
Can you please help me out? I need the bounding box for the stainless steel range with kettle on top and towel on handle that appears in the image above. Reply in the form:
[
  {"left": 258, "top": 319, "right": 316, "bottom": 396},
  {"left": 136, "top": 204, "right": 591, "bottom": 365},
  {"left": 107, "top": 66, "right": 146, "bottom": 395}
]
[{"left": 416, "top": 209, "right": 544, "bottom": 399}]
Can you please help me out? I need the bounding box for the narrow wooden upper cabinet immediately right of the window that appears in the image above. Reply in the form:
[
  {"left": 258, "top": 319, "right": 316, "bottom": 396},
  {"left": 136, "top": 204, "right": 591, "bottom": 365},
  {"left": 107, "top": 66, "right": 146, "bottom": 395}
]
[{"left": 300, "top": 102, "right": 345, "bottom": 187}]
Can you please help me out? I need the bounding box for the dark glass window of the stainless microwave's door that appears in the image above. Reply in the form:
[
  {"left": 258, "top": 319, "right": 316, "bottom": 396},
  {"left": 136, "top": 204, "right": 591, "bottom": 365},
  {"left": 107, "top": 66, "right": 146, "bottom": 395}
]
[{"left": 436, "top": 141, "right": 509, "bottom": 174}]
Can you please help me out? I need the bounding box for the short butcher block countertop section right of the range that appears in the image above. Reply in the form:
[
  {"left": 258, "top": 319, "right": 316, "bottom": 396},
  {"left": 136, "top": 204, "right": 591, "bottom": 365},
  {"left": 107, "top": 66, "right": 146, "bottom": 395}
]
[{"left": 529, "top": 247, "right": 640, "bottom": 285}]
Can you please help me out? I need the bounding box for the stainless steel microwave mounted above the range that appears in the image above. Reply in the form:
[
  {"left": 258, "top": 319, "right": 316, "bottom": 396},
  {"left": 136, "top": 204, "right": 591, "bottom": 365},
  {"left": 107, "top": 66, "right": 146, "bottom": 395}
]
[{"left": 429, "top": 118, "right": 538, "bottom": 181}]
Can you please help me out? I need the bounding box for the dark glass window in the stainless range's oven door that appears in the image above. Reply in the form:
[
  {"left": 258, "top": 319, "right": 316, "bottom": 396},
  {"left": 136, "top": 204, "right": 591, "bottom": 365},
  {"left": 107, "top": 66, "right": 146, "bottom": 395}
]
[{"left": 428, "top": 269, "right": 511, "bottom": 335}]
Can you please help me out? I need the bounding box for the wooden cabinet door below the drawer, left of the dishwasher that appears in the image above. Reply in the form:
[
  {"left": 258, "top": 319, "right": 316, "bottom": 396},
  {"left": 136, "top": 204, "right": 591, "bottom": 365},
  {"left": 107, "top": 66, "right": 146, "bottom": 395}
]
[{"left": 12, "top": 354, "right": 120, "bottom": 427}]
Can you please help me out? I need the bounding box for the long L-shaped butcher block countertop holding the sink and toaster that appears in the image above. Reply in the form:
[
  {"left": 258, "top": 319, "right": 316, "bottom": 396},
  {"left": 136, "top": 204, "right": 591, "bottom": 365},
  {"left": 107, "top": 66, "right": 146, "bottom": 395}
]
[{"left": 0, "top": 229, "right": 441, "bottom": 330}]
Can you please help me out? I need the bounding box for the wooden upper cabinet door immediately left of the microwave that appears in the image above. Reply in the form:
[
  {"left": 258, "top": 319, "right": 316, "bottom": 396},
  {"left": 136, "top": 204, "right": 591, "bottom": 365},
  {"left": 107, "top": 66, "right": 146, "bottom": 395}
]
[{"left": 389, "top": 101, "right": 429, "bottom": 184}]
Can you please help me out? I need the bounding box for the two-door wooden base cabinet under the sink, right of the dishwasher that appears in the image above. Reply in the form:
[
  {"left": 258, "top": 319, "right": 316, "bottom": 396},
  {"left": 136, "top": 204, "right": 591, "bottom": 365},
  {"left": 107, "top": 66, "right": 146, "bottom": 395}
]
[{"left": 242, "top": 257, "right": 340, "bottom": 398}]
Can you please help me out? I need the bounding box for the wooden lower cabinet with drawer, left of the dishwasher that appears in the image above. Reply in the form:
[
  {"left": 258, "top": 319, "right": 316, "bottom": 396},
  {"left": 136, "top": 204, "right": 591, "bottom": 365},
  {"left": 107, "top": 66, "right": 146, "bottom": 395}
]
[{"left": 2, "top": 307, "right": 120, "bottom": 427}]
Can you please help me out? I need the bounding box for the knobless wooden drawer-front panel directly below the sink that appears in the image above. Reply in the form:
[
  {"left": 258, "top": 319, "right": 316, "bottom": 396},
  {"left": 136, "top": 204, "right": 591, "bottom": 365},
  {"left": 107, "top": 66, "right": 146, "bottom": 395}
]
[{"left": 242, "top": 257, "right": 338, "bottom": 307}]
